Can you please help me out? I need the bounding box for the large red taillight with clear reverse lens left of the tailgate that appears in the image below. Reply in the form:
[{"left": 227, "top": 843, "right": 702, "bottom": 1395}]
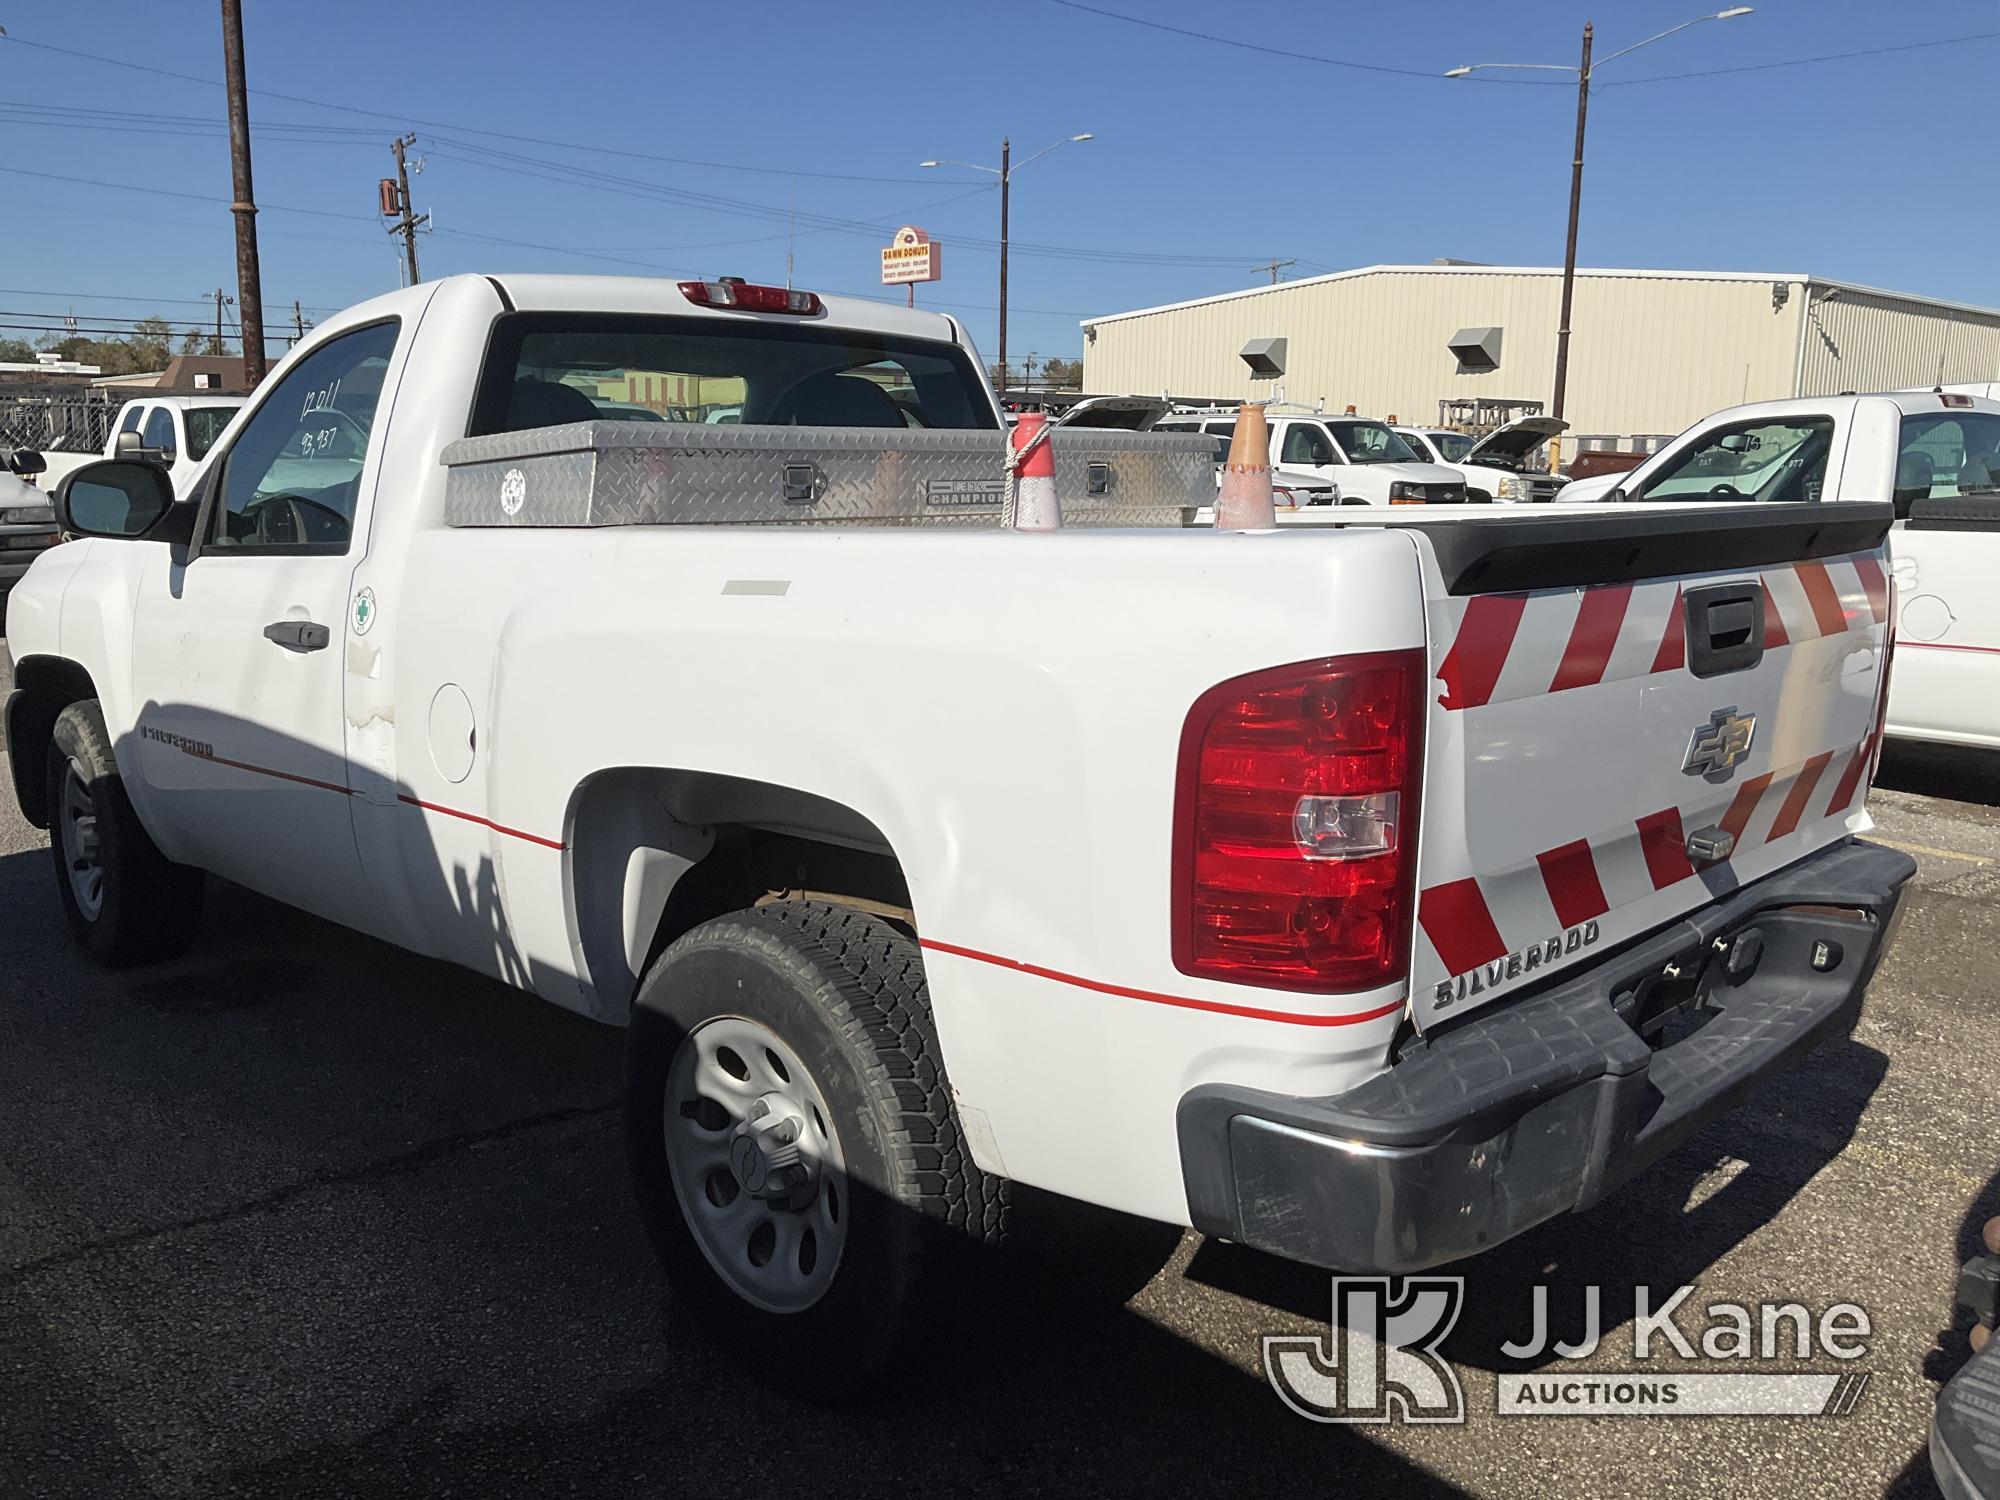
[{"left": 1174, "top": 650, "right": 1428, "bottom": 992}]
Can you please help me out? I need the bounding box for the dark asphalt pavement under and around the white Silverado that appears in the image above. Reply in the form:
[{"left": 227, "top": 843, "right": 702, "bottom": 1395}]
[{"left": 0, "top": 636, "right": 2000, "bottom": 1500}]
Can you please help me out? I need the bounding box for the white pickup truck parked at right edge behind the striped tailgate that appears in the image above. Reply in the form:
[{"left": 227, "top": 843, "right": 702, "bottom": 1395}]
[{"left": 1558, "top": 386, "right": 2000, "bottom": 748}]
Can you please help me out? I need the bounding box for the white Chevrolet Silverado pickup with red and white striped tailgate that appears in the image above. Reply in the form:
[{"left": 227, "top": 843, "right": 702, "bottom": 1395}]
[{"left": 6, "top": 276, "right": 1914, "bottom": 1392}]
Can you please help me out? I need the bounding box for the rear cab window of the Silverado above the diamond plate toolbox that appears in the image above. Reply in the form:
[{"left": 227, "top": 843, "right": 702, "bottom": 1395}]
[{"left": 470, "top": 312, "right": 998, "bottom": 436}]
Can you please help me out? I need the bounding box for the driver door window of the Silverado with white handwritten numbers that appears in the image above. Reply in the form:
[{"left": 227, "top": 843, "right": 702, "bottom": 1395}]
[{"left": 202, "top": 322, "right": 398, "bottom": 556}]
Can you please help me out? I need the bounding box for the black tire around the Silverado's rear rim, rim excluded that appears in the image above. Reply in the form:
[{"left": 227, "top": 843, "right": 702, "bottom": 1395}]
[{"left": 626, "top": 902, "right": 1010, "bottom": 1400}]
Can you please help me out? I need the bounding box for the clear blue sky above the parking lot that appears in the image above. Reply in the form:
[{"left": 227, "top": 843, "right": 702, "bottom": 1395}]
[{"left": 0, "top": 0, "right": 2000, "bottom": 358}]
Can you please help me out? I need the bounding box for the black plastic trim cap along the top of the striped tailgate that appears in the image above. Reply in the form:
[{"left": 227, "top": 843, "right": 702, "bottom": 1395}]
[{"left": 1356, "top": 500, "right": 1896, "bottom": 594}]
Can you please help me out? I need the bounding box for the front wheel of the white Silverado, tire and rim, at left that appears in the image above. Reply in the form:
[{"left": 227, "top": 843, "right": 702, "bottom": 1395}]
[{"left": 48, "top": 700, "right": 202, "bottom": 968}]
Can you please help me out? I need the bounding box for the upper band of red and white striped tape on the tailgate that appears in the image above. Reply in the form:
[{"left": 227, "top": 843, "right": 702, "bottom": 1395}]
[{"left": 1434, "top": 552, "right": 1888, "bottom": 710}]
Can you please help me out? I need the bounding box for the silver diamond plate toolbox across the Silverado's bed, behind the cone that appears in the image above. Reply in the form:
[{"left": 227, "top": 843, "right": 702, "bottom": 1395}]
[{"left": 444, "top": 422, "right": 1216, "bottom": 526}]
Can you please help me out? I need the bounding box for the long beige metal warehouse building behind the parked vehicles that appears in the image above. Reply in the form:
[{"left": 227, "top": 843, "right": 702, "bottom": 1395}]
[{"left": 1084, "top": 262, "right": 2000, "bottom": 434}]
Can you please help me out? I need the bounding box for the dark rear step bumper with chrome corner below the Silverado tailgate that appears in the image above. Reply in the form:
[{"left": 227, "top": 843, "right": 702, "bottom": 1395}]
[{"left": 1180, "top": 840, "right": 1916, "bottom": 1272}]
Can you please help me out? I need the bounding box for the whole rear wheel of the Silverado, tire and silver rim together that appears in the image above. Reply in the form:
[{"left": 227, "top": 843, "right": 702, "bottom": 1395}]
[{"left": 626, "top": 902, "right": 1008, "bottom": 1400}]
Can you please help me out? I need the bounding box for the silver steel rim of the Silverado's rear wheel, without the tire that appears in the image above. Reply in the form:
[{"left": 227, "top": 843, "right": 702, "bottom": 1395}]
[{"left": 664, "top": 1016, "right": 848, "bottom": 1312}]
